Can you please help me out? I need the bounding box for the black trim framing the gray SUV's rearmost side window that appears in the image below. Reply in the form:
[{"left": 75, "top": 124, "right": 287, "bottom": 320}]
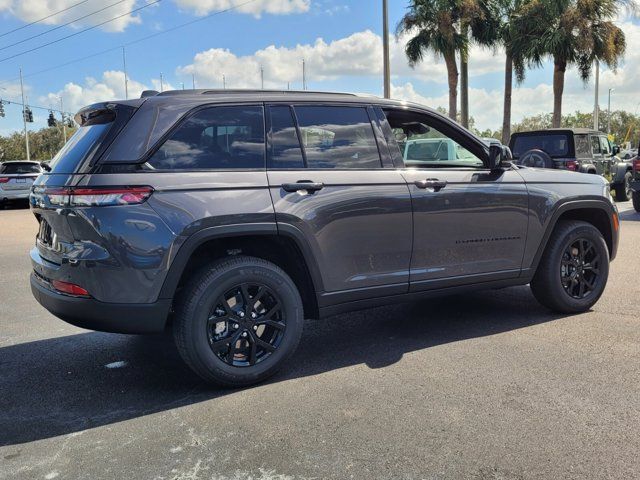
[{"left": 136, "top": 101, "right": 267, "bottom": 173}]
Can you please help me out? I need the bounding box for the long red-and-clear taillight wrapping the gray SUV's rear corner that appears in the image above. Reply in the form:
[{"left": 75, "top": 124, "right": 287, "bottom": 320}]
[{"left": 43, "top": 187, "right": 153, "bottom": 207}]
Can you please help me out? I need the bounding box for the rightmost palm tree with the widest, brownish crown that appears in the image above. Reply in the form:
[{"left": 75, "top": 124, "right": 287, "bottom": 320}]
[{"left": 512, "top": 0, "right": 629, "bottom": 128}]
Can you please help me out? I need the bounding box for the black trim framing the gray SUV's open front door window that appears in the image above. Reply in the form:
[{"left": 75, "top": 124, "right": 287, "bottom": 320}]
[{"left": 380, "top": 105, "right": 491, "bottom": 172}]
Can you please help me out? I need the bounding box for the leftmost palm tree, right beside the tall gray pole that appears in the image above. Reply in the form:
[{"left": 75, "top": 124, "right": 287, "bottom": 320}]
[{"left": 396, "top": 0, "right": 483, "bottom": 124}]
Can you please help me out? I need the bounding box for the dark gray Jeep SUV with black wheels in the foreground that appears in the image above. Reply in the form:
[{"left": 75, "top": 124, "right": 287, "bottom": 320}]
[{"left": 30, "top": 90, "right": 619, "bottom": 386}]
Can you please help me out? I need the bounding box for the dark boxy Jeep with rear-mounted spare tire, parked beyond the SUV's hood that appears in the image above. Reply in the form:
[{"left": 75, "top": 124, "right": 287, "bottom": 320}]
[{"left": 509, "top": 128, "right": 633, "bottom": 202}]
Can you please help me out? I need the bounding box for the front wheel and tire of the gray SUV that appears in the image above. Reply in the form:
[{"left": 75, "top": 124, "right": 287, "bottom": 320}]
[{"left": 531, "top": 220, "right": 609, "bottom": 313}]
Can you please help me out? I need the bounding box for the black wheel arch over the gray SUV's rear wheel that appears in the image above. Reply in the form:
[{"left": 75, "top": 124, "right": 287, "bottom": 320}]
[{"left": 159, "top": 223, "right": 322, "bottom": 318}]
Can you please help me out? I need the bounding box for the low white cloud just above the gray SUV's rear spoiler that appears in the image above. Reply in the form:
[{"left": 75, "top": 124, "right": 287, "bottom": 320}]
[{"left": 40, "top": 70, "right": 174, "bottom": 112}]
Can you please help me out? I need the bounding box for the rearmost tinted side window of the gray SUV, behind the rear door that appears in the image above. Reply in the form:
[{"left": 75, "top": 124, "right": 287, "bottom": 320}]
[{"left": 147, "top": 106, "right": 265, "bottom": 170}]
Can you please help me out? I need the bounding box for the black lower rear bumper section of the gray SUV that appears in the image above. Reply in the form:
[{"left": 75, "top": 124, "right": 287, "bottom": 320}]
[{"left": 31, "top": 273, "right": 171, "bottom": 333}]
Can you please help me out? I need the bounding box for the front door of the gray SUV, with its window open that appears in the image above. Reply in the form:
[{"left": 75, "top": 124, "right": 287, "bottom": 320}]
[{"left": 384, "top": 108, "right": 528, "bottom": 291}]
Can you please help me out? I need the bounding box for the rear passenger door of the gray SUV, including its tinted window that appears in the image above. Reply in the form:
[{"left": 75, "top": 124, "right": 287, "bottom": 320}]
[{"left": 267, "top": 104, "right": 412, "bottom": 306}]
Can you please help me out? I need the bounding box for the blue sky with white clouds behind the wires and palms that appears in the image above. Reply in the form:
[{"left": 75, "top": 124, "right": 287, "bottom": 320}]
[{"left": 0, "top": 0, "right": 640, "bottom": 133}]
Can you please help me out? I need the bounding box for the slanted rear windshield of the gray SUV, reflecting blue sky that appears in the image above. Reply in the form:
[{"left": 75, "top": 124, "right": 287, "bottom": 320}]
[{"left": 49, "top": 122, "right": 113, "bottom": 173}]
